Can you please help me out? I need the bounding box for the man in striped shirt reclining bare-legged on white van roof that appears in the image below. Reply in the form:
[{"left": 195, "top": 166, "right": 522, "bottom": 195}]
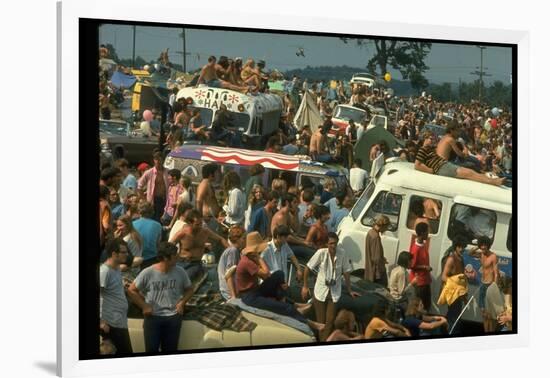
[{"left": 414, "top": 131, "right": 505, "bottom": 185}]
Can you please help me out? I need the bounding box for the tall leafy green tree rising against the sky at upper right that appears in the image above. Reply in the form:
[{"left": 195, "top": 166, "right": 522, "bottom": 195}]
[{"left": 342, "top": 38, "right": 432, "bottom": 91}]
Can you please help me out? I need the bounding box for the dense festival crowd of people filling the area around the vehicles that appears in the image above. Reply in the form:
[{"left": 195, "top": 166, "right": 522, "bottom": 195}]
[{"left": 98, "top": 51, "right": 513, "bottom": 353}]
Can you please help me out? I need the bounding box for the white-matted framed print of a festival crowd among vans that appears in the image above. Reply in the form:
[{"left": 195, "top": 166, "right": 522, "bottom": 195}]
[{"left": 58, "top": 1, "right": 528, "bottom": 375}]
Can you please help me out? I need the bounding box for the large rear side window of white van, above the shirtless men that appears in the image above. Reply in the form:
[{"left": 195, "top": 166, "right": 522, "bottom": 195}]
[{"left": 447, "top": 204, "right": 497, "bottom": 243}]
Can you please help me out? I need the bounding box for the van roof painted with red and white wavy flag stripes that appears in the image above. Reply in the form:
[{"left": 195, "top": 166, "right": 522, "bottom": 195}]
[{"left": 168, "top": 144, "right": 344, "bottom": 176}]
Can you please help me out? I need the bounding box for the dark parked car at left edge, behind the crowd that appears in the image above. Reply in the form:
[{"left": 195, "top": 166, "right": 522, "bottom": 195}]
[{"left": 99, "top": 119, "right": 158, "bottom": 165}]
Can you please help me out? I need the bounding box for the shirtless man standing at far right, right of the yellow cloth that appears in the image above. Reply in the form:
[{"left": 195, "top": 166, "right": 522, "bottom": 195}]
[{"left": 470, "top": 236, "right": 499, "bottom": 332}]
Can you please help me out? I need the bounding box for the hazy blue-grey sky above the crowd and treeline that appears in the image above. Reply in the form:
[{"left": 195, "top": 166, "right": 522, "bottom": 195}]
[{"left": 99, "top": 24, "right": 512, "bottom": 84}]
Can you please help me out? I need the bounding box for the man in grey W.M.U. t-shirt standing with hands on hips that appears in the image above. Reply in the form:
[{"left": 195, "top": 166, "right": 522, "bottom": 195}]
[{"left": 128, "top": 242, "right": 193, "bottom": 353}]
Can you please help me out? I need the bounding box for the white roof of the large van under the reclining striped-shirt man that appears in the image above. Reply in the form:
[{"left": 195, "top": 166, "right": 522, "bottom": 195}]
[{"left": 377, "top": 161, "right": 512, "bottom": 213}]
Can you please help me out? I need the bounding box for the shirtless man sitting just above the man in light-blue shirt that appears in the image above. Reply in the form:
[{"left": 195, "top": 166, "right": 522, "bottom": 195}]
[{"left": 271, "top": 193, "right": 315, "bottom": 258}]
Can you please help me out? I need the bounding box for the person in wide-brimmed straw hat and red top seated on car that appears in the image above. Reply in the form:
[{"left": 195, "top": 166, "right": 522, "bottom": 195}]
[{"left": 237, "top": 231, "right": 323, "bottom": 330}]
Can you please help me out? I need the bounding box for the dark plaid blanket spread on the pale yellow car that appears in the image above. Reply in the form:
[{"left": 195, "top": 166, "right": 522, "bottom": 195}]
[{"left": 197, "top": 304, "right": 257, "bottom": 332}]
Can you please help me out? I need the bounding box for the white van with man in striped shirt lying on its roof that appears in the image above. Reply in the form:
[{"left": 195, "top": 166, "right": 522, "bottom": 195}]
[{"left": 338, "top": 157, "right": 514, "bottom": 321}]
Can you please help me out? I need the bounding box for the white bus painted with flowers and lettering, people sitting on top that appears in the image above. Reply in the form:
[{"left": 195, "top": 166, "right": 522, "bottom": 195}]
[{"left": 176, "top": 85, "right": 283, "bottom": 143}]
